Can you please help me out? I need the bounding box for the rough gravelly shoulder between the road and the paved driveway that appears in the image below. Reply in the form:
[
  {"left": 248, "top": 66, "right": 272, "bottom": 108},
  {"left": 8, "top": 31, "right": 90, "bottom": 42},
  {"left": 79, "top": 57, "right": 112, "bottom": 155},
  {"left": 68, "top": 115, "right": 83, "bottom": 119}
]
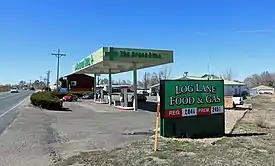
[{"left": 0, "top": 103, "right": 57, "bottom": 166}]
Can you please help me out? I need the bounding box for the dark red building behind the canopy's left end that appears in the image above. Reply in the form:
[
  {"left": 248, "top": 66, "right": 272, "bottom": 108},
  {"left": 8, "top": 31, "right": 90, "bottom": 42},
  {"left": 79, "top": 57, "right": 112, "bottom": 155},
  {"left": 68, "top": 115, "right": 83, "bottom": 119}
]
[{"left": 59, "top": 74, "right": 94, "bottom": 91}]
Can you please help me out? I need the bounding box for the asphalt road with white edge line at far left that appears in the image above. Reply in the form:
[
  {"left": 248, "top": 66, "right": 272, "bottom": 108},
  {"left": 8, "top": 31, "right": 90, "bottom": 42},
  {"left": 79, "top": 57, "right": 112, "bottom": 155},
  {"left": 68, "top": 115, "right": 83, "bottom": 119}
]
[{"left": 0, "top": 91, "right": 33, "bottom": 134}]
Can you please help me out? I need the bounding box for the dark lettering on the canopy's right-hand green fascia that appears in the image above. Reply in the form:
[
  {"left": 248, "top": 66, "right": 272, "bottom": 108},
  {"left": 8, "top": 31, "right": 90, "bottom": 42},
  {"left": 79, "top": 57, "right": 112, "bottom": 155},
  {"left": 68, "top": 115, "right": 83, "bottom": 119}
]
[{"left": 119, "top": 51, "right": 161, "bottom": 59}]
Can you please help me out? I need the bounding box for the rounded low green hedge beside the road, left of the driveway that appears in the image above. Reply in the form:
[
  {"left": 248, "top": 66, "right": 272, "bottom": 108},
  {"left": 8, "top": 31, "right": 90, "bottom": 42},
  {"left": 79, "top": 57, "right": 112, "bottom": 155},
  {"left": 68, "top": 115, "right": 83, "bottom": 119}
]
[{"left": 30, "top": 92, "right": 63, "bottom": 110}]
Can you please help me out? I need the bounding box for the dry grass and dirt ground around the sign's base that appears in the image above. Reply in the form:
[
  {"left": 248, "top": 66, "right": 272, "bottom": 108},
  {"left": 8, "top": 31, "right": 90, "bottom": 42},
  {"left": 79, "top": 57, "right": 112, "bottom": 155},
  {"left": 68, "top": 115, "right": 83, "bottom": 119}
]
[{"left": 55, "top": 95, "right": 275, "bottom": 166}]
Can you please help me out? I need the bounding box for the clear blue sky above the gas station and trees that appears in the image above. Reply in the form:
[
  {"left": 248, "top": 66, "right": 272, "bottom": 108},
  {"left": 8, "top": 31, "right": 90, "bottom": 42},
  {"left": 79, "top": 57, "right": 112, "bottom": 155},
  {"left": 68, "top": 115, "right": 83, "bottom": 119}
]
[{"left": 0, "top": 0, "right": 275, "bottom": 83}]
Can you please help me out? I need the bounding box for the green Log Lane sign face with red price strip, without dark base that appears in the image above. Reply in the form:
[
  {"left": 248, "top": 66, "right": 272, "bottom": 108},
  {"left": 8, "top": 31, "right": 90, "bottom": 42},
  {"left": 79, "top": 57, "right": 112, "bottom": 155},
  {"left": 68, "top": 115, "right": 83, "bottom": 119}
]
[{"left": 161, "top": 80, "right": 224, "bottom": 118}]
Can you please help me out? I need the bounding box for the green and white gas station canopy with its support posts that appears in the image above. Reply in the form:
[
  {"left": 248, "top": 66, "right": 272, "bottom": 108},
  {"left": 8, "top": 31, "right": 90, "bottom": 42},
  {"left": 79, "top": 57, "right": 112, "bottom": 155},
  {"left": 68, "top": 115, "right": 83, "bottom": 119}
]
[{"left": 73, "top": 47, "right": 173, "bottom": 111}]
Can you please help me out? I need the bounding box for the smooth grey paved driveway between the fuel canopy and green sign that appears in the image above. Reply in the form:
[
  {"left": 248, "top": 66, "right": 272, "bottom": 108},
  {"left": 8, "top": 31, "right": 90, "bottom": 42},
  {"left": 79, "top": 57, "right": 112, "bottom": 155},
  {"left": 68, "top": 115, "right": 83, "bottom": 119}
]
[{"left": 58, "top": 101, "right": 155, "bottom": 154}]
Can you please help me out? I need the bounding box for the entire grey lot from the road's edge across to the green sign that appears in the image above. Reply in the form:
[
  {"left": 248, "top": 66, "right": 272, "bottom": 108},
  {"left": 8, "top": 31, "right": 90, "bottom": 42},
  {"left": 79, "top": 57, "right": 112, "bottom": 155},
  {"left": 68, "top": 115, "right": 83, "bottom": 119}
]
[{"left": 0, "top": 99, "right": 155, "bottom": 166}]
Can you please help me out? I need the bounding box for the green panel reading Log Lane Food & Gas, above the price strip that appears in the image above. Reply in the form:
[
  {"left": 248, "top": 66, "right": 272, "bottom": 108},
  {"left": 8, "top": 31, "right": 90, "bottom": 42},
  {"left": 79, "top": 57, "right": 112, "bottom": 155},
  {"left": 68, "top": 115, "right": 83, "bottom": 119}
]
[{"left": 161, "top": 80, "right": 224, "bottom": 113}]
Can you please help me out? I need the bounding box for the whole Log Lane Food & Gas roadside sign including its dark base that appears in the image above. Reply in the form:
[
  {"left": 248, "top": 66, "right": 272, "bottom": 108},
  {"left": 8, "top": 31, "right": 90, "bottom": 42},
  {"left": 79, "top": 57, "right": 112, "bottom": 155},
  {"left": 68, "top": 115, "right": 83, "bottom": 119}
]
[{"left": 160, "top": 80, "right": 224, "bottom": 137}]
